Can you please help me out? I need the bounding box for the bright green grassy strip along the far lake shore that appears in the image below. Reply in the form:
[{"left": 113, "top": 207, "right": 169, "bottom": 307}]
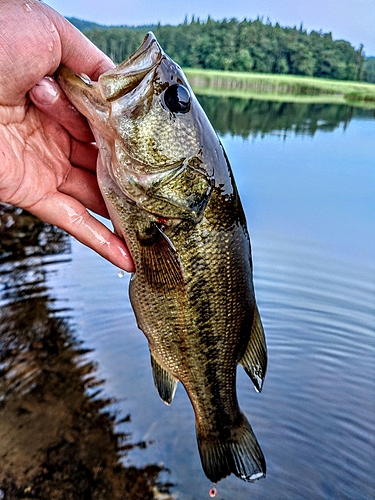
[{"left": 184, "top": 69, "right": 375, "bottom": 108}]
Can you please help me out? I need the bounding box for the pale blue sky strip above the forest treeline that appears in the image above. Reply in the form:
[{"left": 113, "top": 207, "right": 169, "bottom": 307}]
[{"left": 44, "top": 0, "right": 375, "bottom": 56}]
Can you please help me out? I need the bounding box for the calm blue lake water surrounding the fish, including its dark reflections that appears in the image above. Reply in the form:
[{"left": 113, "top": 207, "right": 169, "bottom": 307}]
[{"left": 0, "top": 97, "right": 375, "bottom": 500}]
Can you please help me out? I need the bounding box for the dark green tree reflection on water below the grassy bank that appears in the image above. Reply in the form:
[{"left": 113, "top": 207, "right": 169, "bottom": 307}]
[{"left": 199, "top": 96, "right": 375, "bottom": 138}]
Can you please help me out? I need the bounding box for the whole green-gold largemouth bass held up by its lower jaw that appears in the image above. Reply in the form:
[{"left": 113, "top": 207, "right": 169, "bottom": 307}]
[{"left": 56, "top": 32, "right": 267, "bottom": 483}]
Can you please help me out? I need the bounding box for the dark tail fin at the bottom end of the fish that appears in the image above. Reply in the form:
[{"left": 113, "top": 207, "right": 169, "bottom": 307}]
[{"left": 197, "top": 414, "right": 266, "bottom": 483}]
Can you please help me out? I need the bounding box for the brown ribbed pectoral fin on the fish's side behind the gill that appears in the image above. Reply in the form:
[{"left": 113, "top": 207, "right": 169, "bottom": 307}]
[{"left": 138, "top": 224, "right": 185, "bottom": 293}]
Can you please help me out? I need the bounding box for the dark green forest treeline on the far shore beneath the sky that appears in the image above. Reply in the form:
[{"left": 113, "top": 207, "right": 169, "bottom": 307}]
[{"left": 73, "top": 18, "right": 369, "bottom": 81}]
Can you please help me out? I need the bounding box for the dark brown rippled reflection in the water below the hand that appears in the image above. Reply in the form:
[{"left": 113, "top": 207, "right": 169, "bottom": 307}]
[{"left": 0, "top": 207, "right": 171, "bottom": 500}]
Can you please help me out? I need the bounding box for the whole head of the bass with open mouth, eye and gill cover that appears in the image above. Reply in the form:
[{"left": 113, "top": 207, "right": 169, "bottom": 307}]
[{"left": 57, "top": 33, "right": 223, "bottom": 221}]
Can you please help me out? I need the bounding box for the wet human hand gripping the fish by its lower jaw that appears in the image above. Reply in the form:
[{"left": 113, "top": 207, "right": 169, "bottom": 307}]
[{"left": 0, "top": 0, "right": 134, "bottom": 271}]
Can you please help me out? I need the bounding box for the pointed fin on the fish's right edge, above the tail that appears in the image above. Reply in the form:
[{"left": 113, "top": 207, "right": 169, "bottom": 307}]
[{"left": 240, "top": 305, "right": 267, "bottom": 392}]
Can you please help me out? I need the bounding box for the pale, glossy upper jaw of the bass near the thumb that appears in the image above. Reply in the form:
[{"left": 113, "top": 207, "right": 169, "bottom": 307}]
[{"left": 98, "top": 31, "right": 164, "bottom": 102}]
